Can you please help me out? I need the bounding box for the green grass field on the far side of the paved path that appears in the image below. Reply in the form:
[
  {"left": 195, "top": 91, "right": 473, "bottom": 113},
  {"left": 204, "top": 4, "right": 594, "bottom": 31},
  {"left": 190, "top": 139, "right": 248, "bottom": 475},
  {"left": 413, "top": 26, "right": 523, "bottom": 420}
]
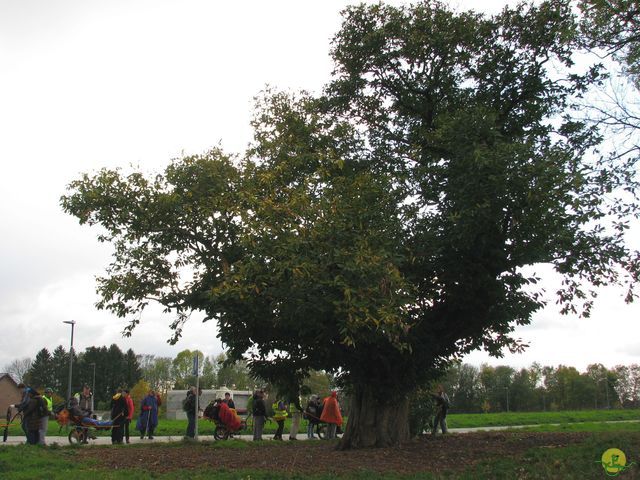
[{"left": 9, "top": 409, "right": 640, "bottom": 436}]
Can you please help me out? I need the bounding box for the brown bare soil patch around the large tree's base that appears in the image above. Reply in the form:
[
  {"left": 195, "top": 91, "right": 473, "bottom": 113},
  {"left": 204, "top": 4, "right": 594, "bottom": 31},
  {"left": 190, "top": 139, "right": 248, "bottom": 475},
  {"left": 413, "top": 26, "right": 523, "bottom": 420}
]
[{"left": 77, "top": 432, "right": 589, "bottom": 474}]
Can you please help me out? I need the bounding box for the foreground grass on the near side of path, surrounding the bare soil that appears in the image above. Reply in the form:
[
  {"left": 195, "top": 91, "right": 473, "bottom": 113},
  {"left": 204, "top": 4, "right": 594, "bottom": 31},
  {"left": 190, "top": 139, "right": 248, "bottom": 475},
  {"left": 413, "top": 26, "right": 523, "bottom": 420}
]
[{"left": 0, "top": 432, "right": 640, "bottom": 480}]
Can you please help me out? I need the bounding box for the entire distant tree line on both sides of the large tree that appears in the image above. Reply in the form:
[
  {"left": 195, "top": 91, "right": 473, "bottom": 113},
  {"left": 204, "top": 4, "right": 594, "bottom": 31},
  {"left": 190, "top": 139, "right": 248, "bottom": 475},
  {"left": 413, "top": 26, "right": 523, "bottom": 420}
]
[{"left": 4, "top": 344, "right": 640, "bottom": 413}]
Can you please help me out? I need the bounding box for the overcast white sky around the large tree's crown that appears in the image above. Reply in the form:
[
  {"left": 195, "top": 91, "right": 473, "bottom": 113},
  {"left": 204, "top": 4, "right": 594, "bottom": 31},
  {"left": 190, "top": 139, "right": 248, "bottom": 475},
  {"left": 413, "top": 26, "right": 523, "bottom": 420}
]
[{"left": 0, "top": 0, "right": 640, "bottom": 370}]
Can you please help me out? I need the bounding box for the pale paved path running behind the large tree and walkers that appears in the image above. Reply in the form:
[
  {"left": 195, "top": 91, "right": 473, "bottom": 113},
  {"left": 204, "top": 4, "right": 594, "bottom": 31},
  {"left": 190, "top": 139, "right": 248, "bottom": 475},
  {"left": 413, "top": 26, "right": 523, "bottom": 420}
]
[{"left": 0, "top": 420, "right": 640, "bottom": 445}]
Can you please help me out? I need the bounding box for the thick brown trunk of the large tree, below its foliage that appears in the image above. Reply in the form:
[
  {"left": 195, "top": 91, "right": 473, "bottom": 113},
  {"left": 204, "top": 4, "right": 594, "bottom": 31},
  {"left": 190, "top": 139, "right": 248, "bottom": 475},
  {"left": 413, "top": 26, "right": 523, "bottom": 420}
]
[{"left": 339, "top": 389, "right": 410, "bottom": 450}]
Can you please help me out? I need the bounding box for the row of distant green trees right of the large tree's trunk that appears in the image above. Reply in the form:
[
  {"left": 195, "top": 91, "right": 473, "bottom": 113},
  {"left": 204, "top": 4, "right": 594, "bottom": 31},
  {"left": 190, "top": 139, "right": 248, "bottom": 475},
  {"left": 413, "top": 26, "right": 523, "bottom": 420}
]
[{"left": 442, "top": 363, "right": 640, "bottom": 413}]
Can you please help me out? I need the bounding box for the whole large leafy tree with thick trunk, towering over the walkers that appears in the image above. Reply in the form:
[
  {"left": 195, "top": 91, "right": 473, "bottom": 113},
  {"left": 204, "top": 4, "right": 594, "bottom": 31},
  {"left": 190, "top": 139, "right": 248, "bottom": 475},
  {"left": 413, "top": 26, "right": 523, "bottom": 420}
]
[{"left": 62, "top": 0, "right": 638, "bottom": 448}]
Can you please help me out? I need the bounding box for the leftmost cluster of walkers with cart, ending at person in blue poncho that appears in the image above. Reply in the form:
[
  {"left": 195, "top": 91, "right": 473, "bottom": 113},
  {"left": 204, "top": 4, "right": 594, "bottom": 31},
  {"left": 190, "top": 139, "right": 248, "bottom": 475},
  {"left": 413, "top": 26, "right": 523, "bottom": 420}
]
[{"left": 10, "top": 383, "right": 162, "bottom": 445}]
